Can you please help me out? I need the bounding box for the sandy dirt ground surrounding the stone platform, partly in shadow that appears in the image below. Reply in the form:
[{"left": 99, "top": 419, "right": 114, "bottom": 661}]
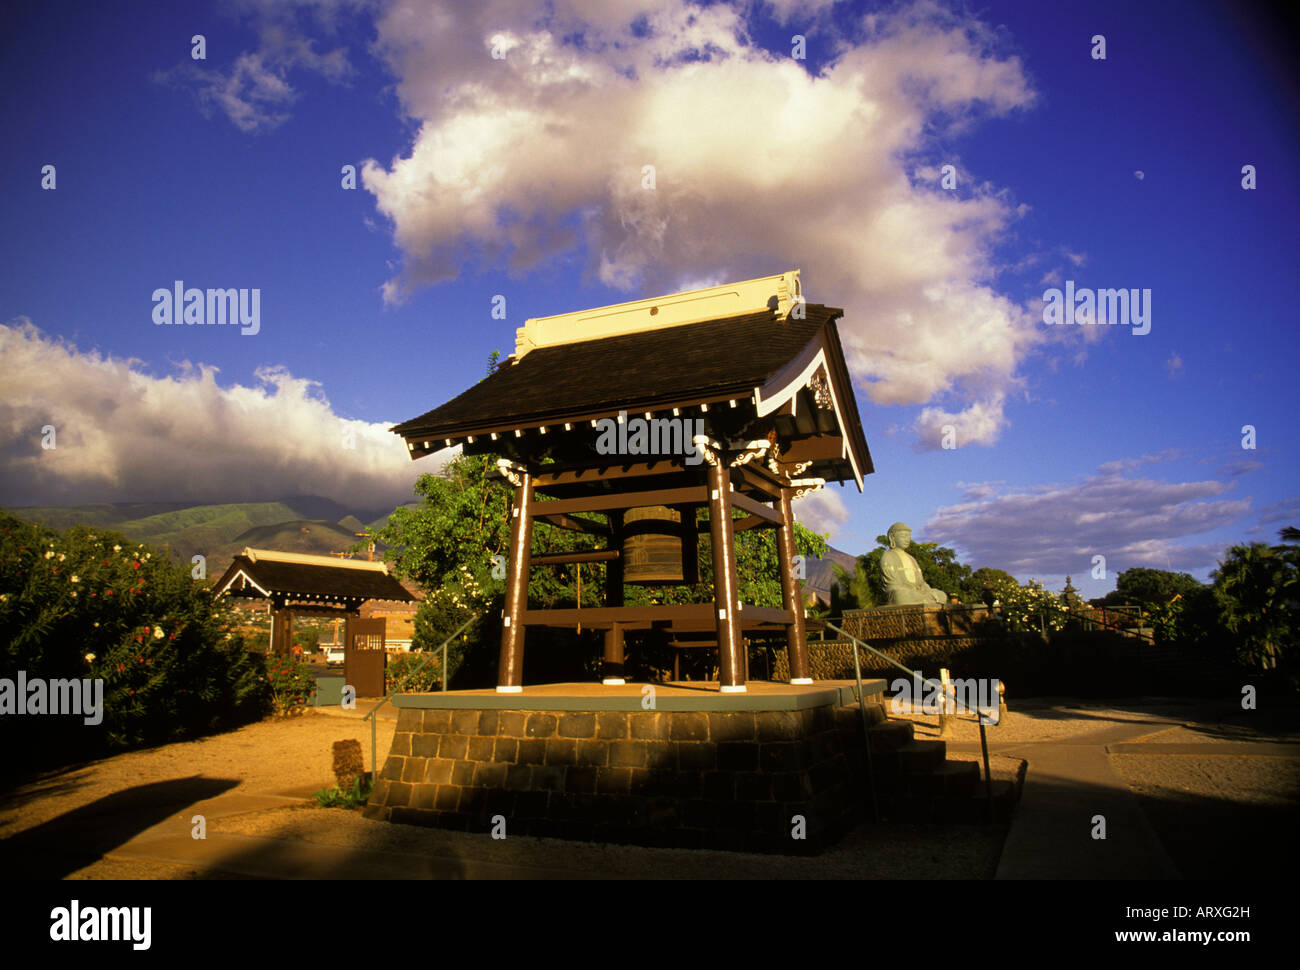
[{"left": 0, "top": 701, "right": 1296, "bottom": 879}]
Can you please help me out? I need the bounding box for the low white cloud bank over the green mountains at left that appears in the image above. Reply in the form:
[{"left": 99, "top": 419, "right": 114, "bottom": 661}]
[{"left": 0, "top": 317, "right": 431, "bottom": 508}]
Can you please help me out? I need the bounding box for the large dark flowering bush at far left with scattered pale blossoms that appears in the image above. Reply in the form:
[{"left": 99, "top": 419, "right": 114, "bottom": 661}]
[{"left": 0, "top": 514, "right": 270, "bottom": 762}]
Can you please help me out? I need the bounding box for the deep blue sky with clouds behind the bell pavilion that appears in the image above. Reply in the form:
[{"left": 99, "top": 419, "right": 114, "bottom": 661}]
[{"left": 0, "top": 0, "right": 1300, "bottom": 596}]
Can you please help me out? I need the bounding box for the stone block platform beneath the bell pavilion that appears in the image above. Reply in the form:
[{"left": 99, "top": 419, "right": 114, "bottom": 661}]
[{"left": 364, "top": 680, "right": 885, "bottom": 854}]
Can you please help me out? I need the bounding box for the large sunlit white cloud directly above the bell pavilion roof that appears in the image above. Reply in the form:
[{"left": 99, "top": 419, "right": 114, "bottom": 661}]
[{"left": 364, "top": 0, "right": 1048, "bottom": 443}]
